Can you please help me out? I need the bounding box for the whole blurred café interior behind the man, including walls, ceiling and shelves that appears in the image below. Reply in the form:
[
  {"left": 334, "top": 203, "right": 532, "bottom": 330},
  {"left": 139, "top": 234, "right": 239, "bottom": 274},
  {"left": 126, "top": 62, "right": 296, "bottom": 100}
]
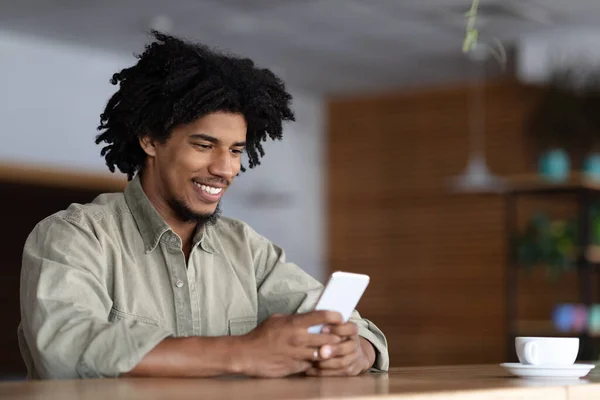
[{"left": 0, "top": 0, "right": 600, "bottom": 379}]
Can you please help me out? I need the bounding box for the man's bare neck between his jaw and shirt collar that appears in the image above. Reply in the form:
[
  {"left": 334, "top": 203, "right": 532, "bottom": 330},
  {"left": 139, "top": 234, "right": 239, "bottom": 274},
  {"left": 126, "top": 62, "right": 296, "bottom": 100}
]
[{"left": 140, "top": 170, "right": 197, "bottom": 244}]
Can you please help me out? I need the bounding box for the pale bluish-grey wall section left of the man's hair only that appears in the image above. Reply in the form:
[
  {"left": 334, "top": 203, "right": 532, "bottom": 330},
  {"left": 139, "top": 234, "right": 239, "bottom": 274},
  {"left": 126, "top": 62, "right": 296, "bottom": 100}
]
[{"left": 0, "top": 33, "right": 123, "bottom": 172}]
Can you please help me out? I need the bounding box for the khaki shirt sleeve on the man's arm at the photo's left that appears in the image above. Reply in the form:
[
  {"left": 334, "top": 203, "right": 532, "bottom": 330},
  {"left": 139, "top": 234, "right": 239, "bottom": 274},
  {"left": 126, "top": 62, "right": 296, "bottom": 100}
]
[{"left": 20, "top": 215, "right": 171, "bottom": 379}]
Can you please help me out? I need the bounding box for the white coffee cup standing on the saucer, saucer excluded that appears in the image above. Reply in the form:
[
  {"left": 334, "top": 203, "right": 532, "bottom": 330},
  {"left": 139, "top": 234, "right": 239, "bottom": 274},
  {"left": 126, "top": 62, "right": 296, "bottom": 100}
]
[{"left": 515, "top": 337, "right": 579, "bottom": 366}]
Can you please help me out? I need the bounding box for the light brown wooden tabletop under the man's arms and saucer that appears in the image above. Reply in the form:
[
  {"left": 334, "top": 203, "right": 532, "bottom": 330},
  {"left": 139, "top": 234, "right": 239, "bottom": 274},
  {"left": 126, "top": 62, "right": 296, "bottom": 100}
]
[{"left": 0, "top": 365, "right": 600, "bottom": 400}]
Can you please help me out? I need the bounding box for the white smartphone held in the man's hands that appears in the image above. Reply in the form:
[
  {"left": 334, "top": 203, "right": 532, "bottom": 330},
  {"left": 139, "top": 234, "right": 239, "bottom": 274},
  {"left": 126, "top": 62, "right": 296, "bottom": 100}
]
[{"left": 308, "top": 271, "right": 370, "bottom": 333}]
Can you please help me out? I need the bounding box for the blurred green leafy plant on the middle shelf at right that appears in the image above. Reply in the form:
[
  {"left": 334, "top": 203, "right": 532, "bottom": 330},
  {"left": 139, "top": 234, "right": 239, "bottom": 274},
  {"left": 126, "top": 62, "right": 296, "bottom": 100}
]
[{"left": 515, "top": 213, "right": 577, "bottom": 279}]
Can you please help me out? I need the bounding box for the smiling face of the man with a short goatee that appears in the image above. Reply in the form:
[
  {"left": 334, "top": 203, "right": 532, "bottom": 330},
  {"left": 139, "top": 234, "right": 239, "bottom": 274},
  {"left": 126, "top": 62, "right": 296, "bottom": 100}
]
[{"left": 141, "top": 112, "right": 247, "bottom": 222}]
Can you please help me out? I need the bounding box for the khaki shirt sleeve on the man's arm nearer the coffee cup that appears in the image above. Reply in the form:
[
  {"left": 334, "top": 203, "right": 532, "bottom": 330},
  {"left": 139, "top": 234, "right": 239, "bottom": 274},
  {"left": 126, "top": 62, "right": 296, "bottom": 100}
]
[{"left": 250, "top": 227, "right": 389, "bottom": 372}]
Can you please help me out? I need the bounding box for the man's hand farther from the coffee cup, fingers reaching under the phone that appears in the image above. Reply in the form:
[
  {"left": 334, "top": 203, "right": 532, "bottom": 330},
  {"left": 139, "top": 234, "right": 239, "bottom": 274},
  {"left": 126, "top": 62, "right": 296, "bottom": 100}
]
[{"left": 238, "top": 311, "right": 344, "bottom": 378}]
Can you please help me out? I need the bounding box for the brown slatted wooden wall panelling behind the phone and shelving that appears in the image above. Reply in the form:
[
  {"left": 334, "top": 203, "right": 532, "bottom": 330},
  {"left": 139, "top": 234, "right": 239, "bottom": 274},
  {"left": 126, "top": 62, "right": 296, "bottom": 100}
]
[{"left": 328, "top": 81, "right": 576, "bottom": 366}]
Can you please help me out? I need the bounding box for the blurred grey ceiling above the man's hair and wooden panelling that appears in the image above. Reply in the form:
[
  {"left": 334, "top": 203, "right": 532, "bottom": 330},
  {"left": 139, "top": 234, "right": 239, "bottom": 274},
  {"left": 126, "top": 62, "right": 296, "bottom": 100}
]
[{"left": 0, "top": 0, "right": 600, "bottom": 94}]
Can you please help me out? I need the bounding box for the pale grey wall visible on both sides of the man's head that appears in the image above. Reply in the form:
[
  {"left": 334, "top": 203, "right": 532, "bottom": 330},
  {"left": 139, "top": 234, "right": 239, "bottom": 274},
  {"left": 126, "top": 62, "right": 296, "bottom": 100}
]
[{"left": 0, "top": 32, "right": 324, "bottom": 278}]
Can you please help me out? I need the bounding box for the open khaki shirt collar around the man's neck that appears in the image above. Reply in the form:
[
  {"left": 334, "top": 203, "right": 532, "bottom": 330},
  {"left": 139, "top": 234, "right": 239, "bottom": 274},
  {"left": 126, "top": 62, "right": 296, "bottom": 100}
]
[{"left": 124, "top": 175, "right": 214, "bottom": 253}]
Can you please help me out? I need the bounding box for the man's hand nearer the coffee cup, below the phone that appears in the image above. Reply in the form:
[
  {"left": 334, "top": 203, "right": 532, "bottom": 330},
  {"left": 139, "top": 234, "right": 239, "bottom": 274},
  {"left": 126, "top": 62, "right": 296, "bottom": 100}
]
[{"left": 306, "top": 322, "right": 375, "bottom": 376}]
